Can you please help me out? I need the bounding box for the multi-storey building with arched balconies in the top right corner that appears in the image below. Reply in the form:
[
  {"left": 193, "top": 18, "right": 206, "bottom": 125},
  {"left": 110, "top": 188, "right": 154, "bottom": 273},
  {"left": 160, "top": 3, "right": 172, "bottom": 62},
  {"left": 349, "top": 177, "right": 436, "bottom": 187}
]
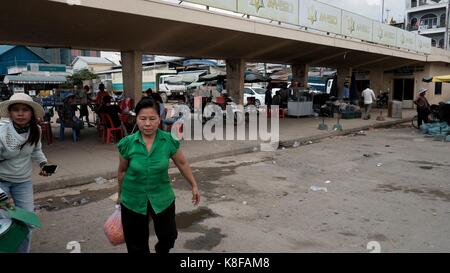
[{"left": 406, "top": 0, "right": 449, "bottom": 49}]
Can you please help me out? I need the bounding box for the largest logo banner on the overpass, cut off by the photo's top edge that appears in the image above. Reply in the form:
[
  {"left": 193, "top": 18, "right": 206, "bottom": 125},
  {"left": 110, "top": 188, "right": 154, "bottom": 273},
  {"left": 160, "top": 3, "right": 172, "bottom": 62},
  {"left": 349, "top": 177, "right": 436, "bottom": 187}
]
[{"left": 238, "top": 0, "right": 298, "bottom": 25}]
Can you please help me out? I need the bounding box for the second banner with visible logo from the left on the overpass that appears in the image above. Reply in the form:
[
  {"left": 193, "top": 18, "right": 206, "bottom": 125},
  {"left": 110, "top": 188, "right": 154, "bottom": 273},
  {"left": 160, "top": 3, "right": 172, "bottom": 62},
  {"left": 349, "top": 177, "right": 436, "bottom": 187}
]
[{"left": 299, "top": 0, "right": 341, "bottom": 34}]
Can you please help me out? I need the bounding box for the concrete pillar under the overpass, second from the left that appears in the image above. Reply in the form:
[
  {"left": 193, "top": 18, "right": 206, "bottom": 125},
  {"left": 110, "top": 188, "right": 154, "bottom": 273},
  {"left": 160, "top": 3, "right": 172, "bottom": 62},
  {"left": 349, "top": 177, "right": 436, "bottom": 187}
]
[{"left": 226, "top": 59, "right": 245, "bottom": 105}]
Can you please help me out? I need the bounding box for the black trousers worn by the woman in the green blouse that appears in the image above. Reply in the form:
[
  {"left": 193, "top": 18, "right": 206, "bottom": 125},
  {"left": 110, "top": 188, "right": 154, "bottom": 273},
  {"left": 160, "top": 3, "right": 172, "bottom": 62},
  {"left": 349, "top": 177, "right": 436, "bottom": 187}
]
[{"left": 121, "top": 201, "right": 178, "bottom": 253}]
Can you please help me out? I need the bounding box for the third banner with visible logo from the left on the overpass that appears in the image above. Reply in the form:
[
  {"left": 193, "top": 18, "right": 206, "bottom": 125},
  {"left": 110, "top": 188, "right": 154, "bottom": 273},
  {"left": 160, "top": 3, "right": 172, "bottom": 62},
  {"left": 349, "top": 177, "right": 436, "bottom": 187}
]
[{"left": 342, "top": 10, "right": 373, "bottom": 42}]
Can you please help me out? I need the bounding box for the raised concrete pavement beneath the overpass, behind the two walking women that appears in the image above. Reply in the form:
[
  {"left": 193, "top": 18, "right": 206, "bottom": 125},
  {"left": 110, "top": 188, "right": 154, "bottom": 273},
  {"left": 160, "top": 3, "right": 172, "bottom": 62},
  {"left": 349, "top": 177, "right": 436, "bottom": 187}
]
[{"left": 33, "top": 109, "right": 415, "bottom": 192}]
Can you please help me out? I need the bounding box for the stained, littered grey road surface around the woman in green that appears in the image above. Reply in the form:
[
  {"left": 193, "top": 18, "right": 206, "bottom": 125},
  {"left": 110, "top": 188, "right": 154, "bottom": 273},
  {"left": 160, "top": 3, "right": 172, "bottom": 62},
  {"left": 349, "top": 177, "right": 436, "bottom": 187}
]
[{"left": 32, "top": 126, "right": 450, "bottom": 253}]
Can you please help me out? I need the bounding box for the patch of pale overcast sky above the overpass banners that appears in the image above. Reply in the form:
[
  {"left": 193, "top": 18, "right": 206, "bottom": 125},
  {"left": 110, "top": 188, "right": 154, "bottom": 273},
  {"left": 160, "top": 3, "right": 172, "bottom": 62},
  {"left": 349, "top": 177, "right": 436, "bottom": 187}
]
[{"left": 320, "top": 0, "right": 405, "bottom": 21}]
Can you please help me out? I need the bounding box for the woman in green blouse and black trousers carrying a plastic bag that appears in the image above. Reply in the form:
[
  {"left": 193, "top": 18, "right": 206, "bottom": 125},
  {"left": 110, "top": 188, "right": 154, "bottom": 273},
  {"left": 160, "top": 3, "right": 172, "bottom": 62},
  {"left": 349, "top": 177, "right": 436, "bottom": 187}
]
[{"left": 118, "top": 97, "right": 200, "bottom": 253}]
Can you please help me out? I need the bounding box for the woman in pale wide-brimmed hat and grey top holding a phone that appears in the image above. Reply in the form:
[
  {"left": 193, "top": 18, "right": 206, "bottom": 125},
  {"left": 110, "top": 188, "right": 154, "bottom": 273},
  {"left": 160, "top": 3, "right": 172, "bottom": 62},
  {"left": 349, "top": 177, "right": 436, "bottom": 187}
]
[{"left": 0, "top": 94, "right": 52, "bottom": 252}]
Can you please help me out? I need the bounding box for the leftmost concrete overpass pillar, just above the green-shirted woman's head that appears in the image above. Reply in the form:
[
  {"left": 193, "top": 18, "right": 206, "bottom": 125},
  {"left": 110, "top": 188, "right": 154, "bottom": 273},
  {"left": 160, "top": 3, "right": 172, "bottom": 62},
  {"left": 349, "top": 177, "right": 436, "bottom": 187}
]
[{"left": 121, "top": 51, "right": 142, "bottom": 103}]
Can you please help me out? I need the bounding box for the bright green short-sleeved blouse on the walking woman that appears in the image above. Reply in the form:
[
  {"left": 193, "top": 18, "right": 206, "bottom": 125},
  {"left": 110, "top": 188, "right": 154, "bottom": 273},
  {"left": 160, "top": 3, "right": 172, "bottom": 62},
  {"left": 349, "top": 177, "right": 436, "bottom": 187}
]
[{"left": 117, "top": 129, "right": 180, "bottom": 214}]
